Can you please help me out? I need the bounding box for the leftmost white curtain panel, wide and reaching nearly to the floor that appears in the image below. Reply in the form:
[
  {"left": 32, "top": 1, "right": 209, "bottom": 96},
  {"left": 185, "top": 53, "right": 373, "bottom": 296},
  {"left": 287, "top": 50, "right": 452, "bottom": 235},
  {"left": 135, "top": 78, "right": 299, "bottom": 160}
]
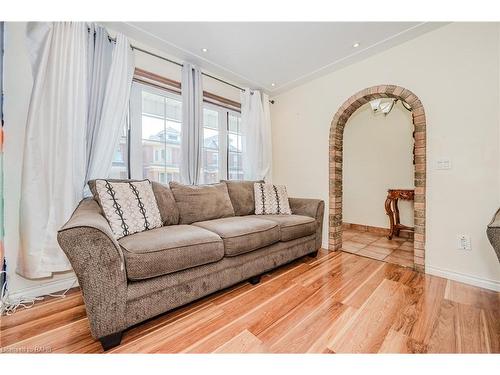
[{"left": 17, "top": 23, "right": 88, "bottom": 278}]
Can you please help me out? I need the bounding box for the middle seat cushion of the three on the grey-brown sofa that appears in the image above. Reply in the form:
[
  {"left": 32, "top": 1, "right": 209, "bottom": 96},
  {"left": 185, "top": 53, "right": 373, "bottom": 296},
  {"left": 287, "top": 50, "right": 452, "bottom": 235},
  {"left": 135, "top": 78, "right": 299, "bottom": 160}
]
[{"left": 193, "top": 216, "right": 280, "bottom": 256}]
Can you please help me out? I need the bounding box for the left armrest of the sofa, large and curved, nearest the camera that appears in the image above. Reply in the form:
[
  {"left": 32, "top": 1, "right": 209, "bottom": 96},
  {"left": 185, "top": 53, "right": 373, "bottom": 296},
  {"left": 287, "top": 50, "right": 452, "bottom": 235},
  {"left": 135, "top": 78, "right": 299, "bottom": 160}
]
[{"left": 57, "top": 198, "right": 127, "bottom": 338}]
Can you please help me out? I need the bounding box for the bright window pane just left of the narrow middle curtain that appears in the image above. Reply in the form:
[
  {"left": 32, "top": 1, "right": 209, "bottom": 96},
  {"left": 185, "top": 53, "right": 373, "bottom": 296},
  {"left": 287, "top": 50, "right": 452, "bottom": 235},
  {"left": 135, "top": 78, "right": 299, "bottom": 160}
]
[{"left": 130, "top": 82, "right": 182, "bottom": 184}]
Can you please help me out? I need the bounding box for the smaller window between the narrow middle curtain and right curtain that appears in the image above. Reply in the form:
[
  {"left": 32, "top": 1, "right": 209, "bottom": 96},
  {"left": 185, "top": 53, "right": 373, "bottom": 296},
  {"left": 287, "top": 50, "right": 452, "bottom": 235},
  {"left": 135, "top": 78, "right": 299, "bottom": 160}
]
[{"left": 200, "top": 103, "right": 243, "bottom": 184}]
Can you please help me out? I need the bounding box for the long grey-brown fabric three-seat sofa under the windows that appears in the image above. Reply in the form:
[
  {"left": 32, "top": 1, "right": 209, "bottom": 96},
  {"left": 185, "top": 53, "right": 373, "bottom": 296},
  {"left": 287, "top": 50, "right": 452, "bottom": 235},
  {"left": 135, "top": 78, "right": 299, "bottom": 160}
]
[{"left": 58, "top": 181, "right": 324, "bottom": 350}]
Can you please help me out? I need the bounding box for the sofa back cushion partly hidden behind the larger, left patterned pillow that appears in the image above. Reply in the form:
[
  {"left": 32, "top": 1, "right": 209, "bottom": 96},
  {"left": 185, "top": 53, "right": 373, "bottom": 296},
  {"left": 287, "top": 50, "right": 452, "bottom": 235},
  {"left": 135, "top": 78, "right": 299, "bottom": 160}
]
[{"left": 88, "top": 179, "right": 179, "bottom": 225}]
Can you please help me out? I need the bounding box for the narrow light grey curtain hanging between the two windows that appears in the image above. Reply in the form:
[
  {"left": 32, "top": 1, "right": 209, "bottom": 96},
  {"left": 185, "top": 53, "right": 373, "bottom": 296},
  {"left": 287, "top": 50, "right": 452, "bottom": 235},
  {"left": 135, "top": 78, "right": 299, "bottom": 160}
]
[{"left": 181, "top": 63, "right": 203, "bottom": 185}]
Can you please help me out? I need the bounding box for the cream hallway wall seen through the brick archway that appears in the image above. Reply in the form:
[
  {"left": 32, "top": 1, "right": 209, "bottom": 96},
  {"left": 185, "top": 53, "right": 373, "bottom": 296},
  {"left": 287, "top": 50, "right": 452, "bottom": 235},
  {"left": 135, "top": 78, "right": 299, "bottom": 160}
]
[{"left": 342, "top": 102, "right": 414, "bottom": 228}]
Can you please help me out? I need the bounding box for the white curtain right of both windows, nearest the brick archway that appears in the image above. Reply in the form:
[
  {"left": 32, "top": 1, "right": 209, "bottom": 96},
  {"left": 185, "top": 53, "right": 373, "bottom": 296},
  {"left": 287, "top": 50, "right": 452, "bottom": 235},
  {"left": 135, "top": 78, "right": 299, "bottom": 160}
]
[{"left": 241, "top": 88, "right": 272, "bottom": 182}]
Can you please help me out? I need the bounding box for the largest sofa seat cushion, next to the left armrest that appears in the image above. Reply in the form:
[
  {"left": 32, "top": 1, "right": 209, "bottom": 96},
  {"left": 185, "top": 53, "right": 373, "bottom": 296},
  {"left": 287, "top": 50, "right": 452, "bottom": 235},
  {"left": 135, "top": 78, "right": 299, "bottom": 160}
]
[{"left": 118, "top": 225, "right": 224, "bottom": 280}]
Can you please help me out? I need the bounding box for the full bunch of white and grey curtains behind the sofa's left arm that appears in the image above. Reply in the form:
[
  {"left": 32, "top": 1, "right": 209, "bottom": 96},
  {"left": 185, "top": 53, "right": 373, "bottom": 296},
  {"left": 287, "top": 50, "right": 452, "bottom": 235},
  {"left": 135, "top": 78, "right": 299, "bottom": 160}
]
[{"left": 17, "top": 22, "right": 134, "bottom": 278}]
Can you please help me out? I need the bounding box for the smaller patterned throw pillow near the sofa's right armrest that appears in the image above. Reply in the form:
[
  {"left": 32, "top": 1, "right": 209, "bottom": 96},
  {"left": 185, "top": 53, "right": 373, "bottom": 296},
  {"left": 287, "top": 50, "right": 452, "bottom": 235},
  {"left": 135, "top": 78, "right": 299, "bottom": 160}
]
[{"left": 253, "top": 182, "right": 292, "bottom": 215}]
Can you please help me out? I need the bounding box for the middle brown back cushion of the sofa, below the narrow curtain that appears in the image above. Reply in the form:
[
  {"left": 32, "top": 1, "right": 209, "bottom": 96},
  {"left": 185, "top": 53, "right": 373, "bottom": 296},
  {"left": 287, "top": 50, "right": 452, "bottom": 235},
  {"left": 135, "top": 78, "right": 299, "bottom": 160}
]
[{"left": 170, "top": 182, "right": 234, "bottom": 224}]
